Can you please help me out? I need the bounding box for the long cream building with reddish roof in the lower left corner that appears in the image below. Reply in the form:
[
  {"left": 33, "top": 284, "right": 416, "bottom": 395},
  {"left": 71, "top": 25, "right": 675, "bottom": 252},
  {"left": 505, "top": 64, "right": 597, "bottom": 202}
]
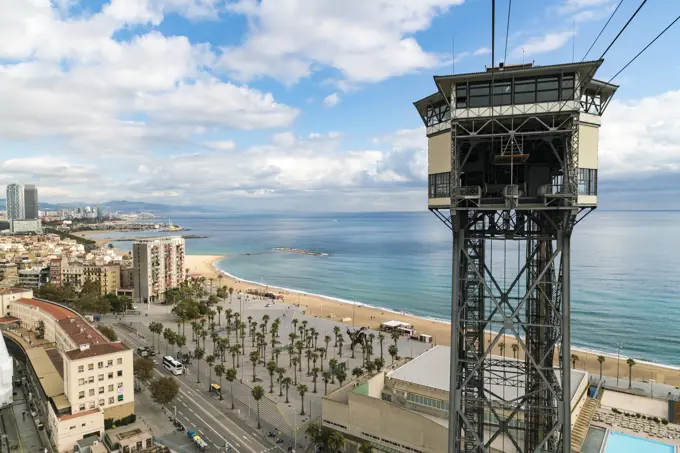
[{"left": 0, "top": 289, "right": 134, "bottom": 452}]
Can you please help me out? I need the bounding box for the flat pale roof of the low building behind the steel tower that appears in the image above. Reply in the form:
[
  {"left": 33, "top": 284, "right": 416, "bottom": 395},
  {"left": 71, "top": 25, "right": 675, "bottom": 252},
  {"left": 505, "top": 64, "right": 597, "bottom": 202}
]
[{"left": 387, "top": 345, "right": 585, "bottom": 401}]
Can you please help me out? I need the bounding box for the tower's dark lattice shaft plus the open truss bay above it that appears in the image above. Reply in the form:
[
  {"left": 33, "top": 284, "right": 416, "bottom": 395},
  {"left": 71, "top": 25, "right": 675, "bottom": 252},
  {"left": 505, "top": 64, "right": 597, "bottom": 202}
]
[{"left": 433, "top": 103, "right": 590, "bottom": 453}]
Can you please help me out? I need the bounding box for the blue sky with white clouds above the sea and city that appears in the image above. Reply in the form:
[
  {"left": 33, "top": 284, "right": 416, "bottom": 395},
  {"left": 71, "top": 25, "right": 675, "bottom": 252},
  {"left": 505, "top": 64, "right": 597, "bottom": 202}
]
[{"left": 0, "top": 0, "right": 680, "bottom": 211}]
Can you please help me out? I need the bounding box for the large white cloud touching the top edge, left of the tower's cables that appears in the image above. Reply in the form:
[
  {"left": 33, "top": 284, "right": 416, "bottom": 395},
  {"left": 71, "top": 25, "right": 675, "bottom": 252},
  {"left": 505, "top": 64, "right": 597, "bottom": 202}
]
[{"left": 220, "top": 0, "right": 463, "bottom": 84}]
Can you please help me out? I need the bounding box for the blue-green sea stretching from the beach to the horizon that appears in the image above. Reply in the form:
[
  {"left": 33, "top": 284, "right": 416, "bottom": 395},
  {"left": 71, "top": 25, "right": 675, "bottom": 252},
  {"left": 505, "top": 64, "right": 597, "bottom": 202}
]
[{"left": 99, "top": 210, "right": 680, "bottom": 366}]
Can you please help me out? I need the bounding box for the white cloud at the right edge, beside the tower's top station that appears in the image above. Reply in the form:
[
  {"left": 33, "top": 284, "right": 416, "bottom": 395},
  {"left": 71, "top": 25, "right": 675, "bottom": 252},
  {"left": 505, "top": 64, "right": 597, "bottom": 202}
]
[{"left": 599, "top": 91, "right": 680, "bottom": 177}]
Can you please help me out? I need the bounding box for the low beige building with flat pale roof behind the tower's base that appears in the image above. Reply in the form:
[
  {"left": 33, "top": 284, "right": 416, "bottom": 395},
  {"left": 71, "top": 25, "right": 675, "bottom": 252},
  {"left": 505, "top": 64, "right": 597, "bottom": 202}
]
[{"left": 322, "top": 346, "right": 588, "bottom": 453}]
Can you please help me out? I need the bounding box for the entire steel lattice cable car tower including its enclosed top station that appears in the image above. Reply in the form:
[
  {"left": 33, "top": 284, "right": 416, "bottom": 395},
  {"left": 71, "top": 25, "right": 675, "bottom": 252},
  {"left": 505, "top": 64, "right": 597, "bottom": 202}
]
[{"left": 415, "top": 60, "right": 618, "bottom": 453}]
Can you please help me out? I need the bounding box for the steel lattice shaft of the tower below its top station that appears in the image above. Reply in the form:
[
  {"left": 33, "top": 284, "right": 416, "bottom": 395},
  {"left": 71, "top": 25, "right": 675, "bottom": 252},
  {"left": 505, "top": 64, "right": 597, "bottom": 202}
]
[{"left": 440, "top": 210, "right": 576, "bottom": 453}]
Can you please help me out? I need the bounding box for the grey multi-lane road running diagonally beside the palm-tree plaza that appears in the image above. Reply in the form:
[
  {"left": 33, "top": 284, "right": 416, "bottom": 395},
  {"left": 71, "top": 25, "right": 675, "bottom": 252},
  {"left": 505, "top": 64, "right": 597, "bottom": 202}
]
[{"left": 113, "top": 325, "right": 286, "bottom": 453}]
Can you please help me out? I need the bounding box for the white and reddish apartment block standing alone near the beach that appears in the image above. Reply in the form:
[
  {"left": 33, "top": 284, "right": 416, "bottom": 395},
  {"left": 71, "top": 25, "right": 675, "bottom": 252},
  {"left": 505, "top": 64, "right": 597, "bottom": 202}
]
[{"left": 132, "top": 236, "right": 185, "bottom": 302}]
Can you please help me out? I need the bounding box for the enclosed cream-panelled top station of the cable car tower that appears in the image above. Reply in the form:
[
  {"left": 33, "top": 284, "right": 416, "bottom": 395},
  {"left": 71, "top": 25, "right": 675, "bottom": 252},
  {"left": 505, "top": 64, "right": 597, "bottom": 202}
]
[{"left": 415, "top": 60, "right": 618, "bottom": 210}]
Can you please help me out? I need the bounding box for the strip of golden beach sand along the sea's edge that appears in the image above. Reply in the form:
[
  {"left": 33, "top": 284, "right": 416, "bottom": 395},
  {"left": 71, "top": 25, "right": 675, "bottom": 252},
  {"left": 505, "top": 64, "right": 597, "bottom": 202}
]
[{"left": 186, "top": 255, "right": 680, "bottom": 386}]
